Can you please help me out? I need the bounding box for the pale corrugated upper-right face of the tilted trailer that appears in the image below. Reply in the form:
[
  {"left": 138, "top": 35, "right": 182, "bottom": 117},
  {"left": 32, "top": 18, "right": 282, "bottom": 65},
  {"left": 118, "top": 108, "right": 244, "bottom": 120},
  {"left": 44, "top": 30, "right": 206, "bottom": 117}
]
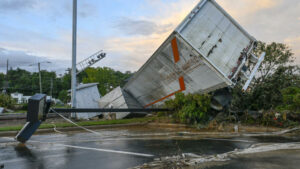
[{"left": 176, "top": 0, "right": 256, "bottom": 78}]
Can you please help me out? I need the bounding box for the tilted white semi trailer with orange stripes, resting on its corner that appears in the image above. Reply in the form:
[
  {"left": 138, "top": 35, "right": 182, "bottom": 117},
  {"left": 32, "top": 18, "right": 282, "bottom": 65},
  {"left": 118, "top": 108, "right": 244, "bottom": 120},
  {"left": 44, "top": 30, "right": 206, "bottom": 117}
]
[{"left": 100, "top": 0, "right": 264, "bottom": 117}]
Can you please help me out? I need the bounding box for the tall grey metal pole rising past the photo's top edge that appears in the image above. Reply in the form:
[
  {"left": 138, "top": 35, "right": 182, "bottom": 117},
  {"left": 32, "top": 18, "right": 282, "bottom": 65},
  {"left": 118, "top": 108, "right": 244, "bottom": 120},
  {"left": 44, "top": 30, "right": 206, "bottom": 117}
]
[{"left": 71, "top": 0, "right": 77, "bottom": 108}]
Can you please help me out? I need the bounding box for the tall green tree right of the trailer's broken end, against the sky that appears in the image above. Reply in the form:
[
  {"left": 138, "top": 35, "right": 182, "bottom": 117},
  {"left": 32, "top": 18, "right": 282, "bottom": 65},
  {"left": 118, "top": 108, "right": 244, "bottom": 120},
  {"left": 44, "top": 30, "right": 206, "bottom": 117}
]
[{"left": 231, "top": 42, "right": 300, "bottom": 110}]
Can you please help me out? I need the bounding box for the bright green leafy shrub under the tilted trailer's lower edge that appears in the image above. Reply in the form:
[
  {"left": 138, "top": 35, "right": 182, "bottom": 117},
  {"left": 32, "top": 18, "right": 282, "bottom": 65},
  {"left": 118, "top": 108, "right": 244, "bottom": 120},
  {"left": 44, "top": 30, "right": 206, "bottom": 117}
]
[{"left": 165, "top": 93, "right": 211, "bottom": 124}]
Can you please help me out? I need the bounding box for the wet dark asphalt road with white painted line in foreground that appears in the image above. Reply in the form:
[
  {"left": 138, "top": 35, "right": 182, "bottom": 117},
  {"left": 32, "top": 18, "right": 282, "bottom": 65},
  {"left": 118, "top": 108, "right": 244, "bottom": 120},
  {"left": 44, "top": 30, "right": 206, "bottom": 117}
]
[{"left": 0, "top": 128, "right": 300, "bottom": 169}]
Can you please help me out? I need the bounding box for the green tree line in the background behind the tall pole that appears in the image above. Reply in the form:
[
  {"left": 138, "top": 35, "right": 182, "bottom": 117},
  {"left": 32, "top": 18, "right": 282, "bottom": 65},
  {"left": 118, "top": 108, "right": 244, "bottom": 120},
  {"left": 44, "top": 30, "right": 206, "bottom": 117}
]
[{"left": 0, "top": 67, "right": 133, "bottom": 103}]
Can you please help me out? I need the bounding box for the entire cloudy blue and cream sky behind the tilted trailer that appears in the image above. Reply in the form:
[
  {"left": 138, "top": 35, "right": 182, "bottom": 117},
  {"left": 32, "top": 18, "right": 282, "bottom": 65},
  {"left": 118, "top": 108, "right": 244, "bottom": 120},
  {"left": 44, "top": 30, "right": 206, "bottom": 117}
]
[{"left": 0, "top": 0, "right": 300, "bottom": 73}]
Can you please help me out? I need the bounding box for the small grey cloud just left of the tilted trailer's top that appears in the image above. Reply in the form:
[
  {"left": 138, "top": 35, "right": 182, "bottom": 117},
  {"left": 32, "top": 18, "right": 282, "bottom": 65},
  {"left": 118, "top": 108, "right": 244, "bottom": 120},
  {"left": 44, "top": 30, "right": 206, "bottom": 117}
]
[{"left": 115, "top": 18, "right": 172, "bottom": 36}]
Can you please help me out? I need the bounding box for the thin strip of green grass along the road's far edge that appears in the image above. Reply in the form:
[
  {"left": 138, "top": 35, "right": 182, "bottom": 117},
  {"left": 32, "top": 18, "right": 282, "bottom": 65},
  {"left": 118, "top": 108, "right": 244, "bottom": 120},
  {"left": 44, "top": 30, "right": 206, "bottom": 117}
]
[{"left": 0, "top": 117, "right": 154, "bottom": 132}]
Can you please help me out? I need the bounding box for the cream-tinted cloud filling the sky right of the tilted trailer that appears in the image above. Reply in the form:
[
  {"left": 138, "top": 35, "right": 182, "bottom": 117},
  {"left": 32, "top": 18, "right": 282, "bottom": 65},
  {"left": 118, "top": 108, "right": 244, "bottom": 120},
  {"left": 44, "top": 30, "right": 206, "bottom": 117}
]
[{"left": 218, "top": 0, "right": 300, "bottom": 64}]
